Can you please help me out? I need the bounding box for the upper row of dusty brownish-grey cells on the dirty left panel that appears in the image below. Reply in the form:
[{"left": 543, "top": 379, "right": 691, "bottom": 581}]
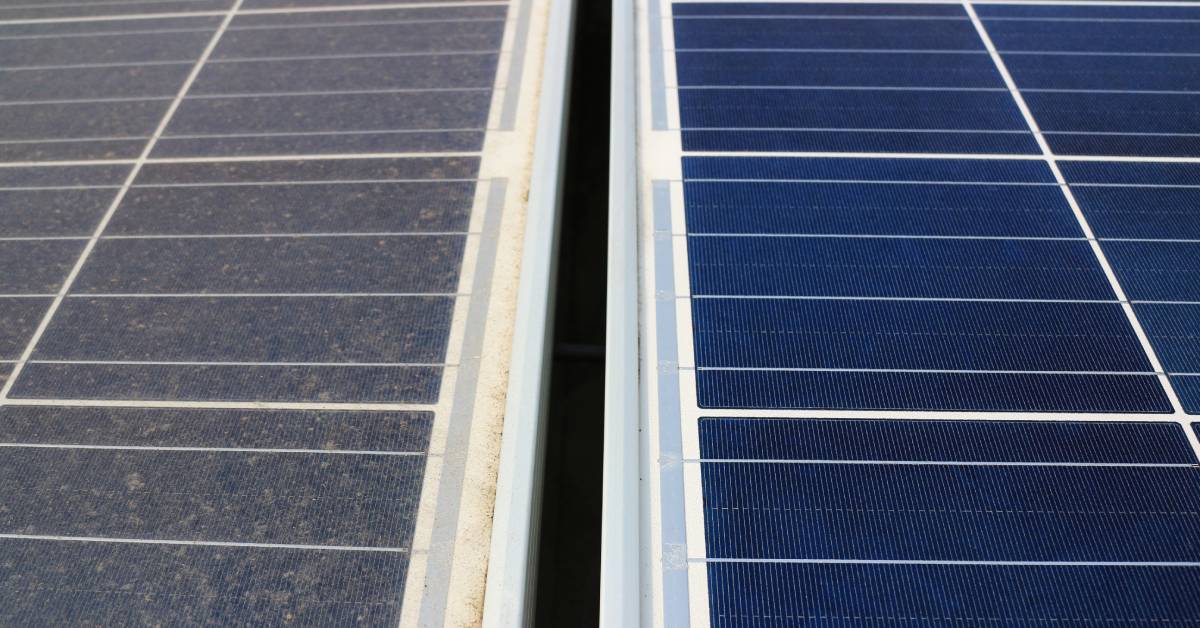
[{"left": 0, "top": 6, "right": 505, "bottom": 161}]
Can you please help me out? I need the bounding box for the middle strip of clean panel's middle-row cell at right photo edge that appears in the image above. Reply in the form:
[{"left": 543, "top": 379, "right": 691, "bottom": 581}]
[{"left": 1102, "top": 240, "right": 1200, "bottom": 301}]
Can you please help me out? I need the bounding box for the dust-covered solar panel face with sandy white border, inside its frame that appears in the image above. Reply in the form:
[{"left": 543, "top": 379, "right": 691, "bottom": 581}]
[{"left": 0, "top": 0, "right": 556, "bottom": 626}]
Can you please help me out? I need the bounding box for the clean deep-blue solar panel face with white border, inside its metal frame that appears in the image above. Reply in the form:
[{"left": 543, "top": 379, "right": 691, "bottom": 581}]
[{"left": 624, "top": 0, "right": 1200, "bottom": 626}]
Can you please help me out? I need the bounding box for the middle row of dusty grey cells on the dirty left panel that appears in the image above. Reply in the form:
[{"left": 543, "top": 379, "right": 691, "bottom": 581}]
[{"left": 0, "top": 159, "right": 478, "bottom": 402}]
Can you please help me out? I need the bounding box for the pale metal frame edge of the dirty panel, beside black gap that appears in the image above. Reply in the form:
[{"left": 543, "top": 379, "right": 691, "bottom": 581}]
[{"left": 484, "top": 0, "right": 575, "bottom": 628}]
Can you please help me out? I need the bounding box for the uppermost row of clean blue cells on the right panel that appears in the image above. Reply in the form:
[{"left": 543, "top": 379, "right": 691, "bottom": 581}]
[{"left": 674, "top": 4, "right": 1200, "bottom": 155}]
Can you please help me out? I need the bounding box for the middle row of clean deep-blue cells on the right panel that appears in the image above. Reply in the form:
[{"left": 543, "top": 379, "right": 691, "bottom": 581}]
[{"left": 684, "top": 157, "right": 1200, "bottom": 412}]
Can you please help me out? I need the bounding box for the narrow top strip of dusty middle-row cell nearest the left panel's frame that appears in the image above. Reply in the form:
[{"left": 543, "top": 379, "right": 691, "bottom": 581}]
[{"left": 133, "top": 157, "right": 479, "bottom": 182}]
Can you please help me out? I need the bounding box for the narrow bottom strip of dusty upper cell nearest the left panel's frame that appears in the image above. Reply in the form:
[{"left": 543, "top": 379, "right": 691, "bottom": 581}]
[{"left": 154, "top": 128, "right": 484, "bottom": 157}]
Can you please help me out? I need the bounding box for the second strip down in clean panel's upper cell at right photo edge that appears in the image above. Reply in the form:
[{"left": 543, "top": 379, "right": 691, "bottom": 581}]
[{"left": 984, "top": 19, "right": 1200, "bottom": 54}]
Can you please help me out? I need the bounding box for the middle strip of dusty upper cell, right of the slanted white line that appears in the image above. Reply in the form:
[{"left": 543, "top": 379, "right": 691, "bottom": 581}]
[{"left": 188, "top": 53, "right": 499, "bottom": 95}]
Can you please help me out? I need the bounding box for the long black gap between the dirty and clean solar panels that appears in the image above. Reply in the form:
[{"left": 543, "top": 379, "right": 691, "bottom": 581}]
[{"left": 535, "top": 0, "right": 611, "bottom": 627}]
